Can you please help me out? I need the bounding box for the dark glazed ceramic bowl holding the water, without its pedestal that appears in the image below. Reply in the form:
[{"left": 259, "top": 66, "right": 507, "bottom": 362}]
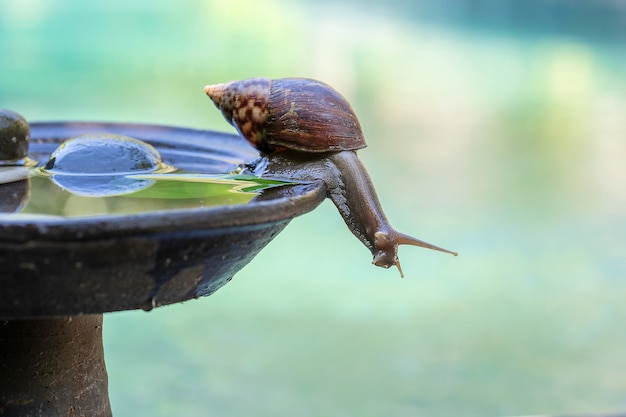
[{"left": 0, "top": 123, "right": 325, "bottom": 318}]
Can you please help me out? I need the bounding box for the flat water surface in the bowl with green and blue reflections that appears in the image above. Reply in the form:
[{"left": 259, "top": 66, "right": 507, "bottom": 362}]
[{"left": 7, "top": 172, "right": 282, "bottom": 217}]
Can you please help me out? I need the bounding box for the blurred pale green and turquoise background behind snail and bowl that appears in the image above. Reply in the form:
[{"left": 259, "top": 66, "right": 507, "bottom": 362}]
[{"left": 0, "top": 0, "right": 626, "bottom": 417}]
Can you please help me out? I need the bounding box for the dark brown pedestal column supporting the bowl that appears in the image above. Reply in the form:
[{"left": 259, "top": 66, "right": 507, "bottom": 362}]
[{"left": 0, "top": 314, "right": 111, "bottom": 417}]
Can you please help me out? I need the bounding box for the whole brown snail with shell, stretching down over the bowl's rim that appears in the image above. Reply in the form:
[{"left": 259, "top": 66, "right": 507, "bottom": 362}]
[{"left": 204, "top": 78, "right": 457, "bottom": 276}]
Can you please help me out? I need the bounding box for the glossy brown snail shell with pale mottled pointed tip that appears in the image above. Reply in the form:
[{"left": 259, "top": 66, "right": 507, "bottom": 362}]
[{"left": 205, "top": 78, "right": 367, "bottom": 153}]
